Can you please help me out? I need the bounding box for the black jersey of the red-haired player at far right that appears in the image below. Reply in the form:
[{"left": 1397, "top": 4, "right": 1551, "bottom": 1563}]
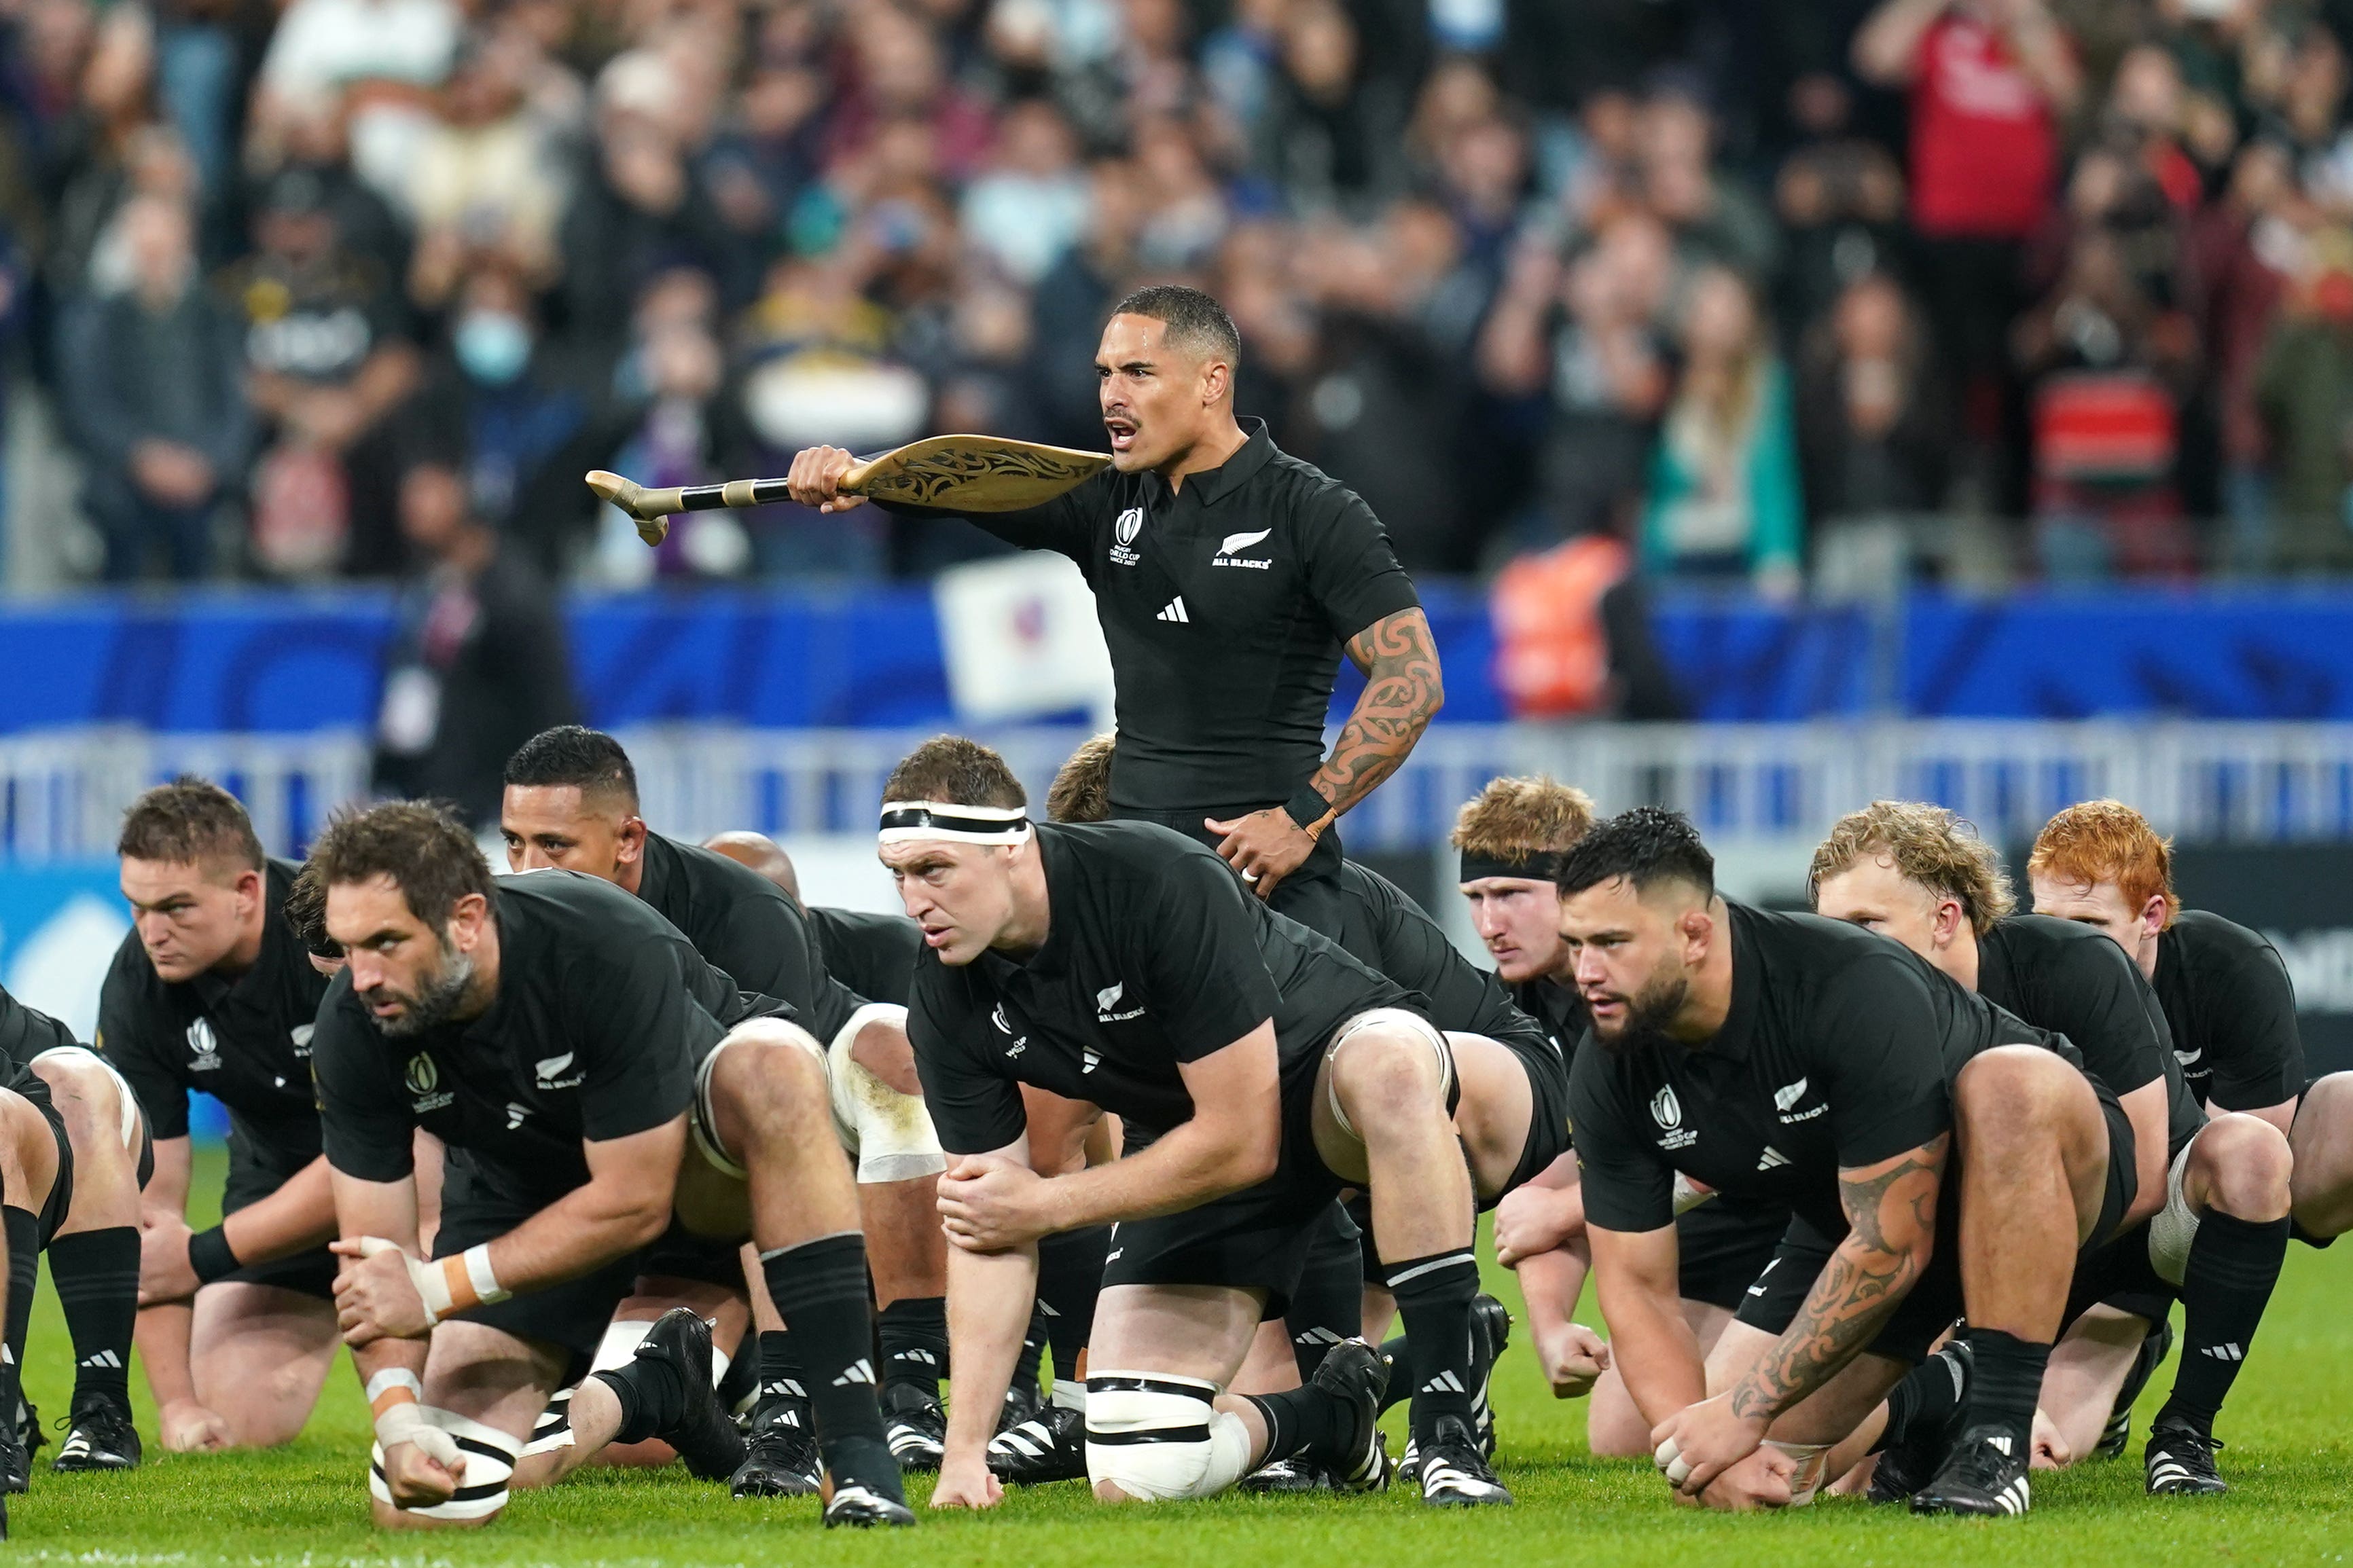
[{"left": 2151, "top": 910, "right": 2303, "bottom": 1110}]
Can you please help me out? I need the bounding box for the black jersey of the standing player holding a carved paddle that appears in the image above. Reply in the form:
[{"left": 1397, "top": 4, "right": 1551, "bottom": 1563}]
[{"left": 884, "top": 418, "right": 1419, "bottom": 811}]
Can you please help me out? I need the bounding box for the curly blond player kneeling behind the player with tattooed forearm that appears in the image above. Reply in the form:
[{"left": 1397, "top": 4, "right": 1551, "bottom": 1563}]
[{"left": 1807, "top": 801, "right": 2289, "bottom": 1497}]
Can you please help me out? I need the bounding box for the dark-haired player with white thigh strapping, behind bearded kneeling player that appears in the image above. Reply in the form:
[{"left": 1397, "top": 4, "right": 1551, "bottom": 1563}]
[{"left": 499, "top": 724, "right": 948, "bottom": 1495}]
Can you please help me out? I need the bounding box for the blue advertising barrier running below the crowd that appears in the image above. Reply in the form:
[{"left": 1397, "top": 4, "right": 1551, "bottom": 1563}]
[{"left": 14, "top": 583, "right": 2353, "bottom": 733}]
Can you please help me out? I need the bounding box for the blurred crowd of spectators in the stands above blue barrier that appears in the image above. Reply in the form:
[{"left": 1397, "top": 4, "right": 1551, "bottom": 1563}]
[{"left": 0, "top": 0, "right": 2353, "bottom": 592}]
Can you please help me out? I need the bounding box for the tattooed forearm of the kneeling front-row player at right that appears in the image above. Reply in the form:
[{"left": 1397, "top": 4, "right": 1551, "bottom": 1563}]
[{"left": 1729, "top": 1137, "right": 1948, "bottom": 1417}]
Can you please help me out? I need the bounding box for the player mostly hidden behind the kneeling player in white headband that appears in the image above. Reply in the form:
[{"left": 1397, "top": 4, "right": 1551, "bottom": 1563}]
[{"left": 1040, "top": 733, "right": 1567, "bottom": 1491}]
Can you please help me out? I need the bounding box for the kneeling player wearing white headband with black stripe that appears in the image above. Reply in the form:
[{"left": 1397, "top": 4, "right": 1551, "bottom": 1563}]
[{"left": 880, "top": 736, "right": 1527, "bottom": 1507}]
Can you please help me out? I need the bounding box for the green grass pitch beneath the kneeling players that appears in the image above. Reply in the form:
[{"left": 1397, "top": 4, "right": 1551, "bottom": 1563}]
[{"left": 0, "top": 1161, "right": 2353, "bottom": 1568}]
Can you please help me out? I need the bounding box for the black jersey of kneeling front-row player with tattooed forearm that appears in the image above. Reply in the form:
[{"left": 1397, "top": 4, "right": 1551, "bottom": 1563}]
[{"left": 1569, "top": 902, "right": 2083, "bottom": 1237}]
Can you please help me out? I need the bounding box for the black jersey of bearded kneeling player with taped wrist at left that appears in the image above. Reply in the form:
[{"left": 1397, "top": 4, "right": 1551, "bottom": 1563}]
[{"left": 310, "top": 870, "right": 788, "bottom": 1208}]
